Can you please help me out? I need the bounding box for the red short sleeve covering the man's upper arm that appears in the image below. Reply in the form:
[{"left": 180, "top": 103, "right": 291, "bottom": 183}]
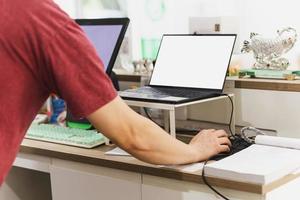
[{"left": 43, "top": 21, "right": 117, "bottom": 118}]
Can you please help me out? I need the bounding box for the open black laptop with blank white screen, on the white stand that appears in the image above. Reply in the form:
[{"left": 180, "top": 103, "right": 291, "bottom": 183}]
[{"left": 119, "top": 34, "right": 237, "bottom": 104}]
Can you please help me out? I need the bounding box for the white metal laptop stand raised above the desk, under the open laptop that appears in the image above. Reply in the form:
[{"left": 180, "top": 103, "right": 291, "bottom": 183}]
[{"left": 124, "top": 94, "right": 235, "bottom": 137}]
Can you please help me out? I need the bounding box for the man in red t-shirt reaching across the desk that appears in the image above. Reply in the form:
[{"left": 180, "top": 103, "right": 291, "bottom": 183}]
[{"left": 0, "top": 0, "right": 230, "bottom": 185}]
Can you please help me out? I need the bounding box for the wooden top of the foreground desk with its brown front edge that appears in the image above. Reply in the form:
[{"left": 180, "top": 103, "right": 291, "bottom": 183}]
[{"left": 20, "top": 139, "right": 298, "bottom": 194}]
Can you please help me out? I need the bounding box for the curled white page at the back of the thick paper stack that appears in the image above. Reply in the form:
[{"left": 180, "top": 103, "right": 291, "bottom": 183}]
[{"left": 255, "top": 135, "right": 300, "bottom": 150}]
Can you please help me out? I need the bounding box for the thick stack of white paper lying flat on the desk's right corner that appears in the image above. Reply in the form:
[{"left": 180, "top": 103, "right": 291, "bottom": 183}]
[{"left": 205, "top": 144, "right": 300, "bottom": 184}]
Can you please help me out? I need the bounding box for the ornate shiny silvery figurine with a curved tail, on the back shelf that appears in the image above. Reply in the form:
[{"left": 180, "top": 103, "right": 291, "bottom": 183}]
[{"left": 241, "top": 27, "right": 297, "bottom": 70}]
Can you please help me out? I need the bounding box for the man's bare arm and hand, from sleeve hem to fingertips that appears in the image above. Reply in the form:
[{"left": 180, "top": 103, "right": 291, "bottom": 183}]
[{"left": 88, "top": 97, "right": 230, "bottom": 164}]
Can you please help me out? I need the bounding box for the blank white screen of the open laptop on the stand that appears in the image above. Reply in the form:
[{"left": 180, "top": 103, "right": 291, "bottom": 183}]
[{"left": 150, "top": 35, "right": 236, "bottom": 90}]
